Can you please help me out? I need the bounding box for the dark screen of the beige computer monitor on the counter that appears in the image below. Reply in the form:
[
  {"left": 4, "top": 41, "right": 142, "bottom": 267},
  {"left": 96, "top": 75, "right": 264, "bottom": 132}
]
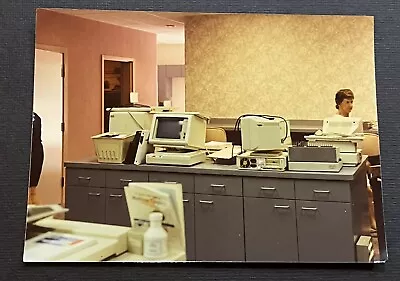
[{"left": 156, "top": 117, "right": 187, "bottom": 140}]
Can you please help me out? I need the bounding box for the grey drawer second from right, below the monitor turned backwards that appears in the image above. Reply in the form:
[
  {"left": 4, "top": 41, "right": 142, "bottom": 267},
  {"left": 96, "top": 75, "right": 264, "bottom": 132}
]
[{"left": 243, "top": 177, "right": 295, "bottom": 199}]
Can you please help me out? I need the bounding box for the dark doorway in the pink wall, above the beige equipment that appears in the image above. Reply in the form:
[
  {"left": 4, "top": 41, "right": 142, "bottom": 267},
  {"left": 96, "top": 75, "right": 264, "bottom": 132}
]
[{"left": 102, "top": 55, "right": 135, "bottom": 133}]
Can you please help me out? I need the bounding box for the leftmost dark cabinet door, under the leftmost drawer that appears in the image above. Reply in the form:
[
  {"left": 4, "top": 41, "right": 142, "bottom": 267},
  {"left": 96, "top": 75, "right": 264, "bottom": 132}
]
[{"left": 65, "top": 186, "right": 88, "bottom": 222}]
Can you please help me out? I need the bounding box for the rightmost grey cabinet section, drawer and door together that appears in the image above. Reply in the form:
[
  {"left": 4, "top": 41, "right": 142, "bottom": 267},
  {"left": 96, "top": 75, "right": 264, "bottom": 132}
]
[{"left": 295, "top": 180, "right": 354, "bottom": 262}]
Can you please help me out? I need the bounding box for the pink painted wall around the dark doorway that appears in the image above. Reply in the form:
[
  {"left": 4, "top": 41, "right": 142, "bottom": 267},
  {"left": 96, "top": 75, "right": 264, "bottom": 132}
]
[{"left": 36, "top": 9, "right": 157, "bottom": 161}]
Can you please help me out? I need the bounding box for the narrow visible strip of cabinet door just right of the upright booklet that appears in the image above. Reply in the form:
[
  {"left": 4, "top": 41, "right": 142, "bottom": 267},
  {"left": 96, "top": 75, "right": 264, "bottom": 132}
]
[{"left": 183, "top": 193, "right": 196, "bottom": 261}]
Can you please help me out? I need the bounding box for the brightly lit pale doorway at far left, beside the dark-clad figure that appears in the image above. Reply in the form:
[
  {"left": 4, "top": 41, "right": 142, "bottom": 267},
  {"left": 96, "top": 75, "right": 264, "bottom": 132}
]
[{"left": 33, "top": 48, "right": 65, "bottom": 205}]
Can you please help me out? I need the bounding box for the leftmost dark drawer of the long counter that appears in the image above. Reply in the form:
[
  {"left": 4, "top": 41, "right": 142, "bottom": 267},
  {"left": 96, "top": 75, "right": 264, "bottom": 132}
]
[{"left": 66, "top": 168, "right": 106, "bottom": 187}]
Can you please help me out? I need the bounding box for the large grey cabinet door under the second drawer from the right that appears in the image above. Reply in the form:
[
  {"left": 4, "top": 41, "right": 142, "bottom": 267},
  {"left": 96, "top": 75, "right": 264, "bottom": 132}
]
[{"left": 244, "top": 197, "right": 298, "bottom": 262}]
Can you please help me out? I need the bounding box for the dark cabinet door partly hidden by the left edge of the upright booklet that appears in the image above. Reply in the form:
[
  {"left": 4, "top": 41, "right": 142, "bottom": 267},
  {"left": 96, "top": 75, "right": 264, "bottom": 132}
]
[{"left": 106, "top": 188, "right": 131, "bottom": 226}]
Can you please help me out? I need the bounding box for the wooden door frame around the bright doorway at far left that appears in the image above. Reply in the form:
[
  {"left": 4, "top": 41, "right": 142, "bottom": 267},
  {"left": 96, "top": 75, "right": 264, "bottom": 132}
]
[{"left": 35, "top": 43, "right": 68, "bottom": 206}]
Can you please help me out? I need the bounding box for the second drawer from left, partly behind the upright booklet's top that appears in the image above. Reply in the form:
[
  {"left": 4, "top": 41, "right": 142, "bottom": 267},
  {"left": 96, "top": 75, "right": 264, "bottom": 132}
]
[{"left": 106, "top": 168, "right": 149, "bottom": 188}]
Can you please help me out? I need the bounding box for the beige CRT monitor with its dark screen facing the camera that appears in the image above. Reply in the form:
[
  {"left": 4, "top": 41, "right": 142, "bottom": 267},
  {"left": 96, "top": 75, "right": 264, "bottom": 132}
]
[{"left": 149, "top": 112, "right": 208, "bottom": 150}]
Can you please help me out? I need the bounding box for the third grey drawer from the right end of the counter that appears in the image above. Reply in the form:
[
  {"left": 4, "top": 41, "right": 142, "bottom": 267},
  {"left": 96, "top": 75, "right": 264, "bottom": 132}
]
[{"left": 194, "top": 175, "right": 242, "bottom": 196}]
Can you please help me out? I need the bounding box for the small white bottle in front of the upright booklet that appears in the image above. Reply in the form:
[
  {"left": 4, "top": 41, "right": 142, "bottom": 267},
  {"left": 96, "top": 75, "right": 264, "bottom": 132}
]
[{"left": 143, "top": 212, "right": 168, "bottom": 259}]
